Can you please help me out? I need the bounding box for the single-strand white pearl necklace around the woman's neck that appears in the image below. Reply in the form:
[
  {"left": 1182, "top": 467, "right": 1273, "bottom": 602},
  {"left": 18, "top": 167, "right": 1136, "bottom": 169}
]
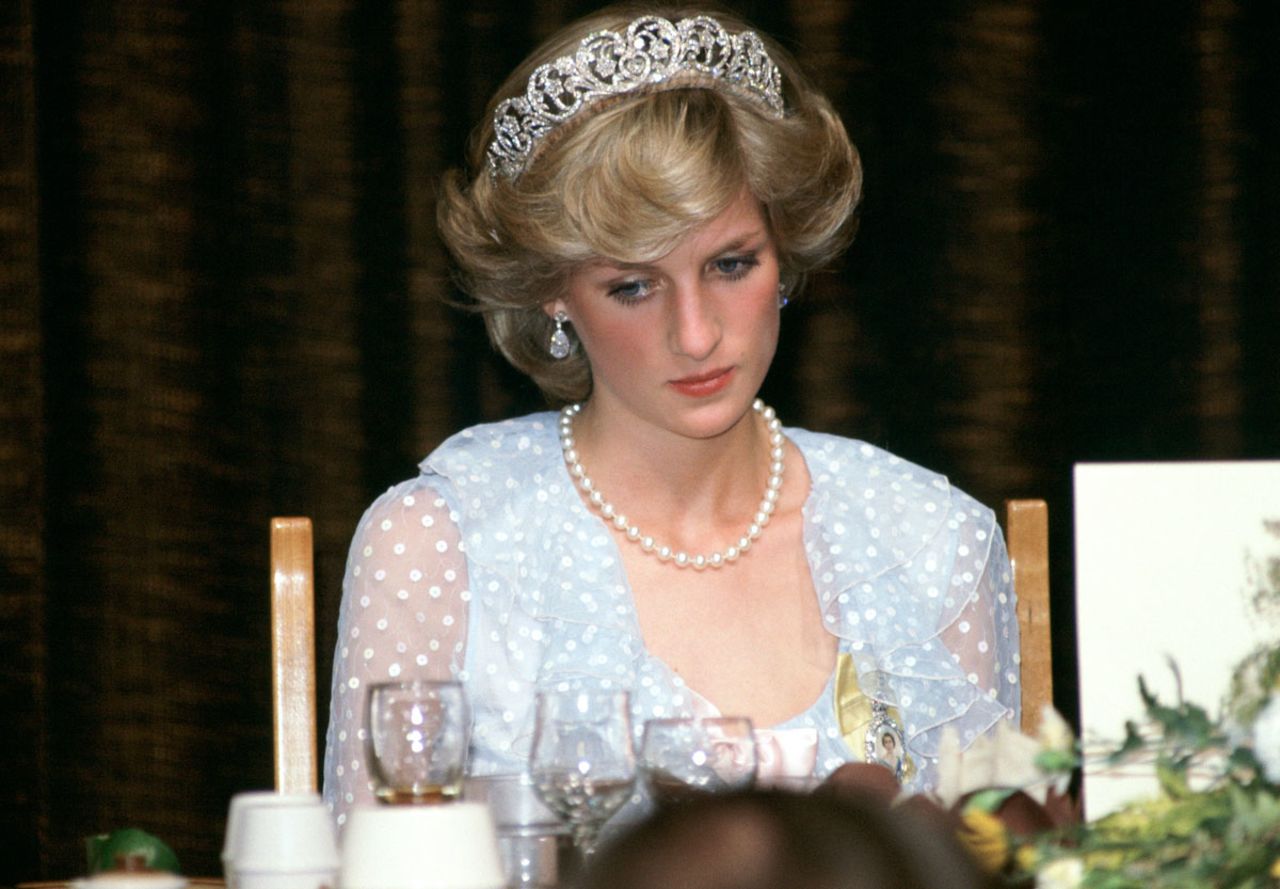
[{"left": 559, "top": 399, "right": 786, "bottom": 570}]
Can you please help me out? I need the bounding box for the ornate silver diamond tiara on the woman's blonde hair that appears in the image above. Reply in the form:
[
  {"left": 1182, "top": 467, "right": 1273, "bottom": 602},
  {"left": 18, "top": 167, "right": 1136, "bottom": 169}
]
[{"left": 489, "top": 15, "right": 783, "bottom": 180}]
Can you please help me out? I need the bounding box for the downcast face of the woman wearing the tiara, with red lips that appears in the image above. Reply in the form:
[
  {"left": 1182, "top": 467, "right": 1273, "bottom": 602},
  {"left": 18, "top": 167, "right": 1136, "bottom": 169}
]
[{"left": 558, "top": 191, "right": 778, "bottom": 437}]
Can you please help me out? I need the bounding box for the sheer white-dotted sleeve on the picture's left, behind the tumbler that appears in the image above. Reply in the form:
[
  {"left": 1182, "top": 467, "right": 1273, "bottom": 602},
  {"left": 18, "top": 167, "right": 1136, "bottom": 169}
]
[{"left": 324, "top": 478, "right": 471, "bottom": 828}]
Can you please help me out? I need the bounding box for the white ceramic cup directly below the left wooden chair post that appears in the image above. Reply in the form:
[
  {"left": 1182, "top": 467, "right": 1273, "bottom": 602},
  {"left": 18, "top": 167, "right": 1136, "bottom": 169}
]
[{"left": 223, "top": 794, "right": 338, "bottom": 889}]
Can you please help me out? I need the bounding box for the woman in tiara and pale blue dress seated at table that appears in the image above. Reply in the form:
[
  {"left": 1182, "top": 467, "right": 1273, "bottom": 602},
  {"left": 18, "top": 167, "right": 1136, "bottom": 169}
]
[{"left": 325, "top": 8, "right": 1018, "bottom": 824}]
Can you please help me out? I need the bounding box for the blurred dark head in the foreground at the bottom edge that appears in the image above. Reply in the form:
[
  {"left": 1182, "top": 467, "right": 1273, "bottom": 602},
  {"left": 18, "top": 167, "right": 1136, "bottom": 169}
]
[{"left": 576, "top": 791, "right": 991, "bottom": 889}]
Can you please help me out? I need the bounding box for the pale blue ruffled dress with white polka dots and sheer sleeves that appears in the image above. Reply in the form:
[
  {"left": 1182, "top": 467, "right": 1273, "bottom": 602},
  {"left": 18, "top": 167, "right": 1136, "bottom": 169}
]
[{"left": 324, "top": 413, "right": 1019, "bottom": 826}]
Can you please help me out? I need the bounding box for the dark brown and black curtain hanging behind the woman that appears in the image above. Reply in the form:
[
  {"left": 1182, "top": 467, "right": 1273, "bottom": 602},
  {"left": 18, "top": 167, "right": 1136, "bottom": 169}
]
[{"left": 0, "top": 0, "right": 1280, "bottom": 884}]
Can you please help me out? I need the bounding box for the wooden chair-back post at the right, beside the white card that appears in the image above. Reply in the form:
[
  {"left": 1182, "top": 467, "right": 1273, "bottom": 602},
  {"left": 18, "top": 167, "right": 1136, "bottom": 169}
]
[{"left": 1005, "top": 500, "right": 1053, "bottom": 734}]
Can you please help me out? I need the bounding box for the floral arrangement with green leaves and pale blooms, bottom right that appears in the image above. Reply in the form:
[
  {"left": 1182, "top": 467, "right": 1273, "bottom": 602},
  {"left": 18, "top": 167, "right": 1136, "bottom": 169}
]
[{"left": 940, "top": 522, "right": 1280, "bottom": 889}]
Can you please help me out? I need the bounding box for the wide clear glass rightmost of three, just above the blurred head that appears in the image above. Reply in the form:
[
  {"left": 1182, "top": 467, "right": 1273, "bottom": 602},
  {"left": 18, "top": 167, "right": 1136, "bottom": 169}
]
[{"left": 640, "top": 716, "right": 756, "bottom": 805}]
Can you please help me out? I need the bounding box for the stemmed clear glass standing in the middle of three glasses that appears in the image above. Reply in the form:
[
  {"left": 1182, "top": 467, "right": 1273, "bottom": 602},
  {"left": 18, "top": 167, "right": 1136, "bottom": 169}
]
[{"left": 529, "top": 691, "right": 636, "bottom": 856}]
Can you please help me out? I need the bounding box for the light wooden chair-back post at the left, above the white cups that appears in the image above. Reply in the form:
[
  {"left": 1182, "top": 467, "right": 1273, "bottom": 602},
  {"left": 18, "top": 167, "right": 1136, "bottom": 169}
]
[{"left": 271, "top": 518, "right": 317, "bottom": 793}]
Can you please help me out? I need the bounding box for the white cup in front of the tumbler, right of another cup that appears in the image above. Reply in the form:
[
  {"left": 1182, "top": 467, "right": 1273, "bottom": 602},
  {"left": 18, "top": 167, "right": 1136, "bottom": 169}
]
[{"left": 338, "top": 802, "right": 506, "bottom": 889}]
